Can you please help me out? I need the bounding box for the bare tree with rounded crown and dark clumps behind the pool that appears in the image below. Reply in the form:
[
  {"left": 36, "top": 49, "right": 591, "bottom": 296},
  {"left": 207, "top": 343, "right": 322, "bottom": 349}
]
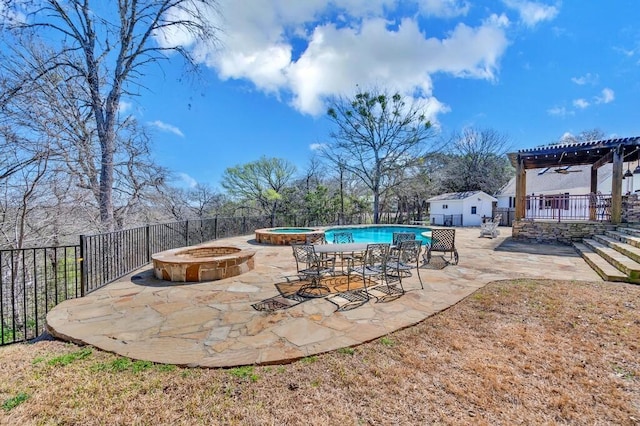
[{"left": 322, "top": 89, "right": 434, "bottom": 223}]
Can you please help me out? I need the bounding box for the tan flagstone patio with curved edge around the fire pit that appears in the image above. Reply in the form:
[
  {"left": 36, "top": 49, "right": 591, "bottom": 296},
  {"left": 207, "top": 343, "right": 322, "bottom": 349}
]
[{"left": 47, "top": 228, "right": 601, "bottom": 367}]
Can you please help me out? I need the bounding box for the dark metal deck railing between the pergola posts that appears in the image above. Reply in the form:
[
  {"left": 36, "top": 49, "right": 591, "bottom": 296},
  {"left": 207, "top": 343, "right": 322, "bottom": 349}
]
[{"left": 524, "top": 194, "right": 611, "bottom": 222}]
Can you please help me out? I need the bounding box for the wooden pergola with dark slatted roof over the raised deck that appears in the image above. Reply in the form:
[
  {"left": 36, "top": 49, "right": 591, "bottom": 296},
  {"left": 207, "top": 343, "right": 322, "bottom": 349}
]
[{"left": 507, "top": 136, "right": 640, "bottom": 224}]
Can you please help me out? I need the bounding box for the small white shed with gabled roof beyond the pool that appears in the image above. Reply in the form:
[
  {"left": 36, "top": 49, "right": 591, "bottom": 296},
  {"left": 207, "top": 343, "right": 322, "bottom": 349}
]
[{"left": 427, "top": 191, "right": 498, "bottom": 226}]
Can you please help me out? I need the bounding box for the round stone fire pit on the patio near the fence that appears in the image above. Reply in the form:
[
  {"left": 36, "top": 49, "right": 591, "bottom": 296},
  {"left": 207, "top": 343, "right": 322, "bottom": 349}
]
[{"left": 151, "top": 244, "right": 256, "bottom": 282}]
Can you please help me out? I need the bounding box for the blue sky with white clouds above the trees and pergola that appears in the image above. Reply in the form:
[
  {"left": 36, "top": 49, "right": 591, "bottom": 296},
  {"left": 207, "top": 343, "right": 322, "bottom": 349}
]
[{"left": 123, "top": 0, "right": 640, "bottom": 188}]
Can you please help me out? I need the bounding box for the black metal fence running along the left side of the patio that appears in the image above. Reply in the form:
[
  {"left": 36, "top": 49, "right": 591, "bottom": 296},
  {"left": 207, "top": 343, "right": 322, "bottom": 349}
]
[{"left": 0, "top": 216, "right": 278, "bottom": 345}]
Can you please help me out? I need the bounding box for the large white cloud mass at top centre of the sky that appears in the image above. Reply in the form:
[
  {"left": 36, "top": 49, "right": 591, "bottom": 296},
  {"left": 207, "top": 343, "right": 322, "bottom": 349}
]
[{"left": 155, "top": 0, "right": 509, "bottom": 122}]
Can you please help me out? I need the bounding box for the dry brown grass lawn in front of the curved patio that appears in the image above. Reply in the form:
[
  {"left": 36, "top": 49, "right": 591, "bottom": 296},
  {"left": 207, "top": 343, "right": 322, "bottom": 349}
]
[{"left": 0, "top": 280, "right": 640, "bottom": 425}]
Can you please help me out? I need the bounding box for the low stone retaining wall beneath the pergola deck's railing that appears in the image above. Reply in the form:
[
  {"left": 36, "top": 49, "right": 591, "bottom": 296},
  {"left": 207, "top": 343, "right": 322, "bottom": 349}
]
[{"left": 511, "top": 220, "right": 616, "bottom": 245}]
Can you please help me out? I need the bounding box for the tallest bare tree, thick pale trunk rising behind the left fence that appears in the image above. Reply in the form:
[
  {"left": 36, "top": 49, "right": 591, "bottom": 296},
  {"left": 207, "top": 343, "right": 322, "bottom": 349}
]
[{"left": 0, "top": 0, "right": 218, "bottom": 229}]
